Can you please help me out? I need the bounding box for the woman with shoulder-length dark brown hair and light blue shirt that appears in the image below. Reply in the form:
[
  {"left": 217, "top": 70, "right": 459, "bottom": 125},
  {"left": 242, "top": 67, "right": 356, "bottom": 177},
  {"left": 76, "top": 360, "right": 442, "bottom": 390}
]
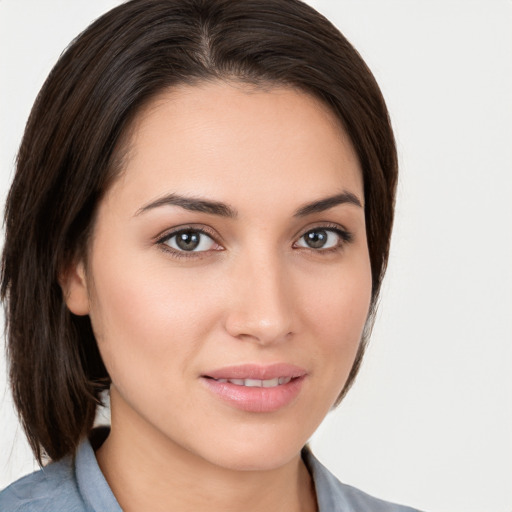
[{"left": 0, "top": 0, "right": 422, "bottom": 512}]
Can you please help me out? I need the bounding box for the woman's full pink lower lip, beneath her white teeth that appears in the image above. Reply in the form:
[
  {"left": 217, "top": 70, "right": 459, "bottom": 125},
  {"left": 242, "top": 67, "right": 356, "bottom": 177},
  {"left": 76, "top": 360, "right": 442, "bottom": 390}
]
[{"left": 202, "top": 376, "right": 305, "bottom": 412}]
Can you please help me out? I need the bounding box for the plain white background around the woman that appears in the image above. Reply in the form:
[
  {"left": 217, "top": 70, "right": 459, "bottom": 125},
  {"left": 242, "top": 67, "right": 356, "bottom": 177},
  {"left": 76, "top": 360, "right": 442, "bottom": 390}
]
[{"left": 0, "top": 0, "right": 512, "bottom": 512}]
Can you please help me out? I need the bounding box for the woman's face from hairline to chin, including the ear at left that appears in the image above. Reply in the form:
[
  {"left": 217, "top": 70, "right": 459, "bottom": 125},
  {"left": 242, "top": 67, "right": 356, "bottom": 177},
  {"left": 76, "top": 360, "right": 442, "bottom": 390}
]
[{"left": 67, "top": 83, "right": 371, "bottom": 469}]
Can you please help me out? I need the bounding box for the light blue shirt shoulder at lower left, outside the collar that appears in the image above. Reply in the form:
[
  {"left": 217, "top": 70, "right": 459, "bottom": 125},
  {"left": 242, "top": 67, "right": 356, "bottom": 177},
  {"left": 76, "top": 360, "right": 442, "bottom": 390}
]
[{"left": 0, "top": 458, "right": 85, "bottom": 512}]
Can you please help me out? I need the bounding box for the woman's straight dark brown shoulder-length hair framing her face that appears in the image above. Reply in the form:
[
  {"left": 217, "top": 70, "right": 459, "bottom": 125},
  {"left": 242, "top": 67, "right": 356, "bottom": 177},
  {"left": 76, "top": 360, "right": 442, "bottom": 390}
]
[{"left": 1, "top": 0, "right": 397, "bottom": 462}]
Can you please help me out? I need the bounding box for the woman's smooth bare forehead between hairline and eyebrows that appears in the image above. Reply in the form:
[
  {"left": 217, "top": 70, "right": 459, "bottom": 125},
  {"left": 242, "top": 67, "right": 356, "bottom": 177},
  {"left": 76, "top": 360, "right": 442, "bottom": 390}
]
[{"left": 106, "top": 82, "right": 364, "bottom": 213}]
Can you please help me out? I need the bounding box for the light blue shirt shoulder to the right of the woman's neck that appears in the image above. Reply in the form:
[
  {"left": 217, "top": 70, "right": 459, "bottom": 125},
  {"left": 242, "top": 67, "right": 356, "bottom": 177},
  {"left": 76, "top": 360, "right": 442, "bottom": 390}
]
[{"left": 302, "top": 447, "right": 426, "bottom": 512}]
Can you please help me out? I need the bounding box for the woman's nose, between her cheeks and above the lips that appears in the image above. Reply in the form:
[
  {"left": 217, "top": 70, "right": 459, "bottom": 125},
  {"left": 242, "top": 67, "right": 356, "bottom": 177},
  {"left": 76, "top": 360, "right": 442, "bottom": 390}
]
[{"left": 225, "top": 250, "right": 297, "bottom": 345}]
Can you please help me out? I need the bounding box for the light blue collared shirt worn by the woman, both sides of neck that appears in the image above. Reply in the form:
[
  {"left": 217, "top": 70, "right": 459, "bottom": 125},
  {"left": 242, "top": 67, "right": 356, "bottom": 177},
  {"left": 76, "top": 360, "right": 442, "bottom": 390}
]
[{"left": 0, "top": 430, "right": 424, "bottom": 512}]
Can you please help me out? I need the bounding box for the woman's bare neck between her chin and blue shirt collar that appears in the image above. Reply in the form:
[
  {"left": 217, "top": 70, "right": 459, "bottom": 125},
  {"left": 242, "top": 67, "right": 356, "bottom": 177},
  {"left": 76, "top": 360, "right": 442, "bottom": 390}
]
[{"left": 96, "top": 394, "right": 316, "bottom": 512}]
